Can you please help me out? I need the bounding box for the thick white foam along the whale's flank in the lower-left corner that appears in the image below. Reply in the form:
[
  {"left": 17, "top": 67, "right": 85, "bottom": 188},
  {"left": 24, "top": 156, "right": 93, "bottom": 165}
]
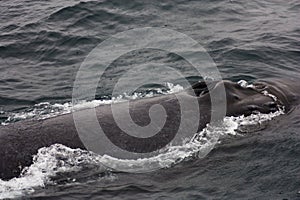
[{"left": 0, "top": 144, "right": 106, "bottom": 199}]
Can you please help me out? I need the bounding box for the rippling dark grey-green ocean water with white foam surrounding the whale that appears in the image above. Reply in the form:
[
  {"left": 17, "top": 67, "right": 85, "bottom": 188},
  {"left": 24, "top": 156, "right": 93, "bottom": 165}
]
[{"left": 0, "top": 0, "right": 300, "bottom": 200}]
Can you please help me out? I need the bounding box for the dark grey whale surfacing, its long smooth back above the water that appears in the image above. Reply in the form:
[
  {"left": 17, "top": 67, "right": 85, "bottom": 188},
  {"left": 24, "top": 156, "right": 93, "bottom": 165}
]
[{"left": 0, "top": 79, "right": 299, "bottom": 180}]
